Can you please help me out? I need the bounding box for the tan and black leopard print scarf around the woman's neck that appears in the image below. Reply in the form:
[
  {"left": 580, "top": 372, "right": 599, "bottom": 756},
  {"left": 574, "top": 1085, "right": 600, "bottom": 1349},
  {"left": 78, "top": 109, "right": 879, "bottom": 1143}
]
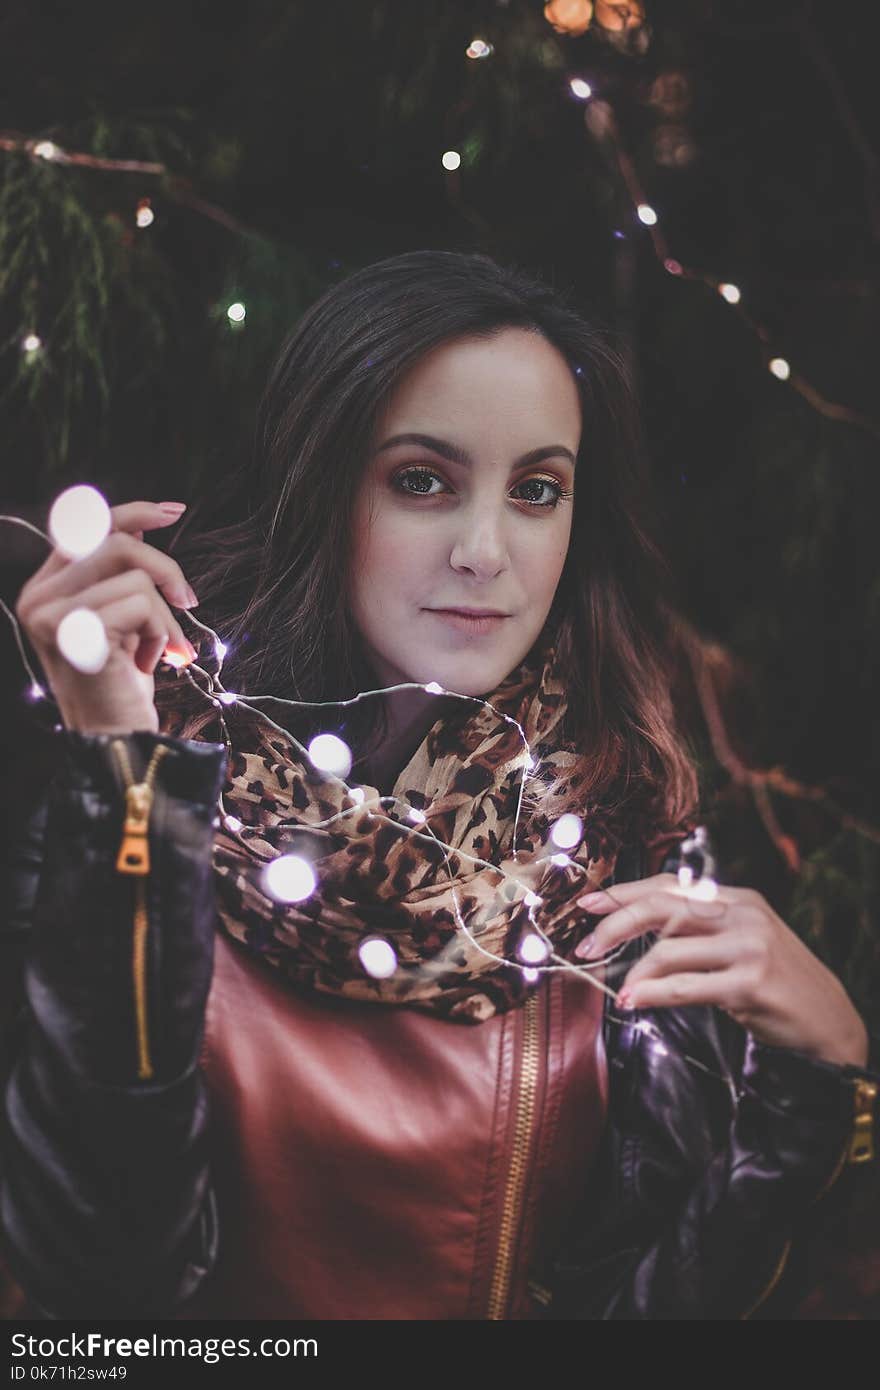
[{"left": 214, "top": 638, "right": 620, "bottom": 1023}]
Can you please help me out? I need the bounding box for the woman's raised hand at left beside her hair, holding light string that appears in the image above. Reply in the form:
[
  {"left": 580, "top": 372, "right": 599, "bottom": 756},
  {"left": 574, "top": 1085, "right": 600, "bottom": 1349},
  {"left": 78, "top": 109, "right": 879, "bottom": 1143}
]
[{"left": 15, "top": 502, "right": 197, "bottom": 734}]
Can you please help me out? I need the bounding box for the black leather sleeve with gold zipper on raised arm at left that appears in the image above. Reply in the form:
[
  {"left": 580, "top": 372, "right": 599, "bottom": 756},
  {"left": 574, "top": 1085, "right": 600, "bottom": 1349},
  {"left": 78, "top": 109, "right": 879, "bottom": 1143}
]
[{"left": 0, "top": 730, "right": 225, "bottom": 1318}]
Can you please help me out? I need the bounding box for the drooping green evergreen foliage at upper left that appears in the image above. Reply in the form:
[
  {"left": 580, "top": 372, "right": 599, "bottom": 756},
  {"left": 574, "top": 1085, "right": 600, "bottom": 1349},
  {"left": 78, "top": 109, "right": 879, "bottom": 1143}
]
[{"left": 0, "top": 118, "right": 182, "bottom": 475}]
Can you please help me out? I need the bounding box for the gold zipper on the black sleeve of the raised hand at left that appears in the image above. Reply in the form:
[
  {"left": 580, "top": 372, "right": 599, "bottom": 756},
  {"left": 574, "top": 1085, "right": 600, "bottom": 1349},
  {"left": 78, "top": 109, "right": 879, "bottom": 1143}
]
[{"left": 113, "top": 738, "right": 168, "bottom": 1081}]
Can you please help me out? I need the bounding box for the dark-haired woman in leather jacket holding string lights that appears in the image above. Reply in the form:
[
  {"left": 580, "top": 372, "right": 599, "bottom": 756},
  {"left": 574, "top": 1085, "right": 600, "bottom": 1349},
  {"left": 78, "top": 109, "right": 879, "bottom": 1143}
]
[{"left": 0, "top": 252, "right": 880, "bottom": 1318}]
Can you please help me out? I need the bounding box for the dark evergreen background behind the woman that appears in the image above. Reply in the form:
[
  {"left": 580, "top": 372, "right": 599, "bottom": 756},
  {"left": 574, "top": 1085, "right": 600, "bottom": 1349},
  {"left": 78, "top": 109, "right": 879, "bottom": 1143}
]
[{"left": 0, "top": 0, "right": 880, "bottom": 1289}]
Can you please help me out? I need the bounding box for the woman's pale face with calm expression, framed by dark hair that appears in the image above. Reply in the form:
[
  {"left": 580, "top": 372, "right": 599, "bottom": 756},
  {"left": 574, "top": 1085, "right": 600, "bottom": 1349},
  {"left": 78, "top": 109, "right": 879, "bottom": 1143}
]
[{"left": 352, "top": 328, "right": 581, "bottom": 695}]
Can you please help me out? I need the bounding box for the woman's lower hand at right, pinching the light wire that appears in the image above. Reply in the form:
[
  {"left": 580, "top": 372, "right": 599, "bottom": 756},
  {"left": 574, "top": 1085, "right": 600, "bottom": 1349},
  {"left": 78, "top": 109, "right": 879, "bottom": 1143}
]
[{"left": 576, "top": 873, "right": 869, "bottom": 1066}]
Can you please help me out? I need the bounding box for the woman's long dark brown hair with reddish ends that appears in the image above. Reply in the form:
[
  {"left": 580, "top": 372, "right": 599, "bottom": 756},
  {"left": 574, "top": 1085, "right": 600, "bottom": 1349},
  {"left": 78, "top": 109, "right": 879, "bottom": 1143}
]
[{"left": 156, "top": 250, "right": 696, "bottom": 831}]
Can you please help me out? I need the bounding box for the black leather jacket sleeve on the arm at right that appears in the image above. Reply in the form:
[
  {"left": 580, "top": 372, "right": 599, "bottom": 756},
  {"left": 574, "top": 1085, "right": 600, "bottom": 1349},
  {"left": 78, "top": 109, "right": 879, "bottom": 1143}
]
[{"left": 544, "top": 961, "right": 880, "bottom": 1319}]
